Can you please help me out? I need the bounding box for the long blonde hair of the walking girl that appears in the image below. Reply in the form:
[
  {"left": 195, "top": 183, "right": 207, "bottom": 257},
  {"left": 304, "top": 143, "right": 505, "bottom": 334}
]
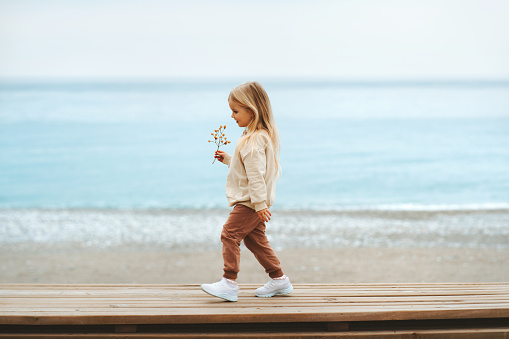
[{"left": 228, "top": 81, "right": 281, "bottom": 176}]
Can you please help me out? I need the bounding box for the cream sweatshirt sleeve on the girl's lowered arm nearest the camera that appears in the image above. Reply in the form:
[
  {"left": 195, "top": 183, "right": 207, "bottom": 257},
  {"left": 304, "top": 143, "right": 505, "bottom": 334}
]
[{"left": 241, "top": 138, "right": 267, "bottom": 212}]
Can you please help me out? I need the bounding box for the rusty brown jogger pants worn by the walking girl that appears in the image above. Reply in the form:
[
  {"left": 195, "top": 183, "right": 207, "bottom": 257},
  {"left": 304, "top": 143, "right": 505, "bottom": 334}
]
[{"left": 221, "top": 205, "right": 283, "bottom": 279}]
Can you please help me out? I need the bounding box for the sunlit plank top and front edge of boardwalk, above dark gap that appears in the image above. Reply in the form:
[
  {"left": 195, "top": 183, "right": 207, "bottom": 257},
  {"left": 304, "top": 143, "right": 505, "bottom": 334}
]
[{"left": 0, "top": 283, "right": 509, "bottom": 325}]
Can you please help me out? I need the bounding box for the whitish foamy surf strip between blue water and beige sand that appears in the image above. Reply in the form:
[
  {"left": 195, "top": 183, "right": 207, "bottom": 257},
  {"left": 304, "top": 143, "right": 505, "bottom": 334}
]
[{"left": 0, "top": 209, "right": 509, "bottom": 252}]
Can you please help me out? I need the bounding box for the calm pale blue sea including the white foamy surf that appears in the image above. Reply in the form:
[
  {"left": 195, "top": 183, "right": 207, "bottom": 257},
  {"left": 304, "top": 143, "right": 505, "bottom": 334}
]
[{"left": 0, "top": 79, "right": 509, "bottom": 247}]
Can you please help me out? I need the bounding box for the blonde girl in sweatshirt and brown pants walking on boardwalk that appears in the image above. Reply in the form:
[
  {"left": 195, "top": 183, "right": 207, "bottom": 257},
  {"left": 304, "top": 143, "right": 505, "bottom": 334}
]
[{"left": 201, "top": 81, "right": 293, "bottom": 301}]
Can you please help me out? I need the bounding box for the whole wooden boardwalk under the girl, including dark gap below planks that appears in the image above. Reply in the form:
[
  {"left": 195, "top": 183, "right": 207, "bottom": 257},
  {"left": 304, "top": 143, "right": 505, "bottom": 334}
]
[{"left": 0, "top": 283, "right": 509, "bottom": 338}]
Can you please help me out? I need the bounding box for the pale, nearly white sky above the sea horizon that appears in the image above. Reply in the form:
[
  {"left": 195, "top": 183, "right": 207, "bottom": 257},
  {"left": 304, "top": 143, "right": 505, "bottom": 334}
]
[{"left": 0, "top": 0, "right": 509, "bottom": 80}]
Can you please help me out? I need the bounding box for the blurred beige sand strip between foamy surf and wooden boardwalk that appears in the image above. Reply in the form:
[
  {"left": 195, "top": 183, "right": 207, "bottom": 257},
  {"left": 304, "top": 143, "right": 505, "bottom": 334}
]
[{"left": 0, "top": 245, "right": 509, "bottom": 284}]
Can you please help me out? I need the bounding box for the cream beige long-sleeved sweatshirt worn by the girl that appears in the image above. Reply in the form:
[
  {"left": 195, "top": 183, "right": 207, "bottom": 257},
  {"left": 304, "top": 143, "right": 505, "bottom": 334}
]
[{"left": 223, "top": 131, "right": 276, "bottom": 212}]
